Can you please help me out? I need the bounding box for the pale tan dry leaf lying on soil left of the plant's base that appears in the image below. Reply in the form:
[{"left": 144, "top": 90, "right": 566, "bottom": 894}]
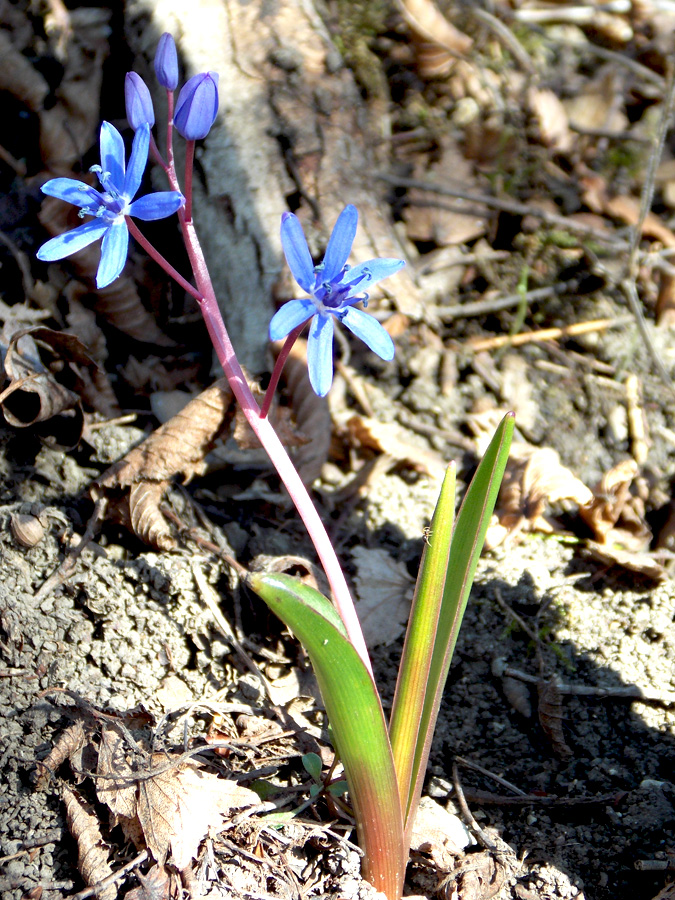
[{"left": 138, "top": 754, "right": 260, "bottom": 869}]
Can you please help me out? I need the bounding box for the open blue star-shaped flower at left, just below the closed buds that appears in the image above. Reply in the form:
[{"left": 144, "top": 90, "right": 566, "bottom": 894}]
[{"left": 37, "top": 122, "right": 185, "bottom": 288}]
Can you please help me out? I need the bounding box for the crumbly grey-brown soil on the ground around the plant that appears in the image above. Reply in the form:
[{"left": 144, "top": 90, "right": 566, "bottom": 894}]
[{"left": 0, "top": 3, "right": 675, "bottom": 900}]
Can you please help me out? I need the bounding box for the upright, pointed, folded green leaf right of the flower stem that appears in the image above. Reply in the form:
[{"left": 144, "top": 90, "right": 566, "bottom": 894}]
[{"left": 390, "top": 413, "right": 514, "bottom": 832}]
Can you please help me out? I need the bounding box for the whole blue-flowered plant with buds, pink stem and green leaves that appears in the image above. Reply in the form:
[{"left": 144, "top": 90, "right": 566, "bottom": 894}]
[{"left": 38, "top": 34, "right": 513, "bottom": 900}]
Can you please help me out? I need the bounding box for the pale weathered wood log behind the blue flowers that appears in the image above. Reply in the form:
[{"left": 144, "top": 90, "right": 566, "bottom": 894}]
[{"left": 125, "top": 0, "right": 420, "bottom": 372}]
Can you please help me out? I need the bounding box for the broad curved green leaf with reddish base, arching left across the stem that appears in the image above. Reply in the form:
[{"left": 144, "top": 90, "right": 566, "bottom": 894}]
[{"left": 247, "top": 573, "right": 407, "bottom": 900}]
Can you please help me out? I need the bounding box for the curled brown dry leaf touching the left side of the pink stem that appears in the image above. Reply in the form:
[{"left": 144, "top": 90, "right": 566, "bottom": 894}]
[{"left": 91, "top": 378, "right": 233, "bottom": 550}]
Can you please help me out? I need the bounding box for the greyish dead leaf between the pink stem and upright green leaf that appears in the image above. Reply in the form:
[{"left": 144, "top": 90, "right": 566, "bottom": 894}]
[{"left": 351, "top": 546, "right": 415, "bottom": 647}]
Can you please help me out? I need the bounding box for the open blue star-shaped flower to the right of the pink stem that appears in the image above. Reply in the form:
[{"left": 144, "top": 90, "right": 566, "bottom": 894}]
[{"left": 270, "top": 204, "right": 405, "bottom": 397}]
